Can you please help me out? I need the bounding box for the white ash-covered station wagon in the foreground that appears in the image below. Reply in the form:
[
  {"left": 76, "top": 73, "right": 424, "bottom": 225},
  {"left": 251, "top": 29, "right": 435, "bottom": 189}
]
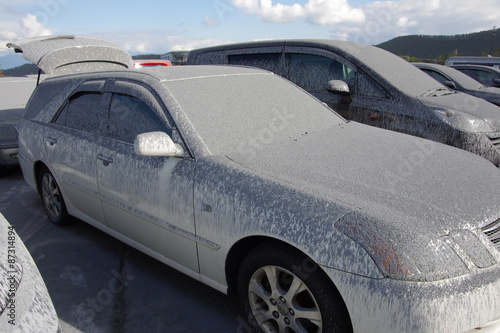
[{"left": 11, "top": 35, "right": 500, "bottom": 333}]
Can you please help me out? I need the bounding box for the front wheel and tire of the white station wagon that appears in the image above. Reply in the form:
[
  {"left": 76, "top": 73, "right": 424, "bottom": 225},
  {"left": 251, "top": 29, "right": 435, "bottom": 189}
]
[{"left": 238, "top": 244, "right": 352, "bottom": 333}]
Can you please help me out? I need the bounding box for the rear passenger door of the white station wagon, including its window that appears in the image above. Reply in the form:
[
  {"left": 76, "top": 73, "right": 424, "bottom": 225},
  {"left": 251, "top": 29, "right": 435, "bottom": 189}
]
[{"left": 43, "top": 80, "right": 109, "bottom": 223}]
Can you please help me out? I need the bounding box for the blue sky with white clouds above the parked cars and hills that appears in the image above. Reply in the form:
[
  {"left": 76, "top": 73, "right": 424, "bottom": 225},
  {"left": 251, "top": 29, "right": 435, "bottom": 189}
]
[{"left": 0, "top": 0, "right": 500, "bottom": 68}]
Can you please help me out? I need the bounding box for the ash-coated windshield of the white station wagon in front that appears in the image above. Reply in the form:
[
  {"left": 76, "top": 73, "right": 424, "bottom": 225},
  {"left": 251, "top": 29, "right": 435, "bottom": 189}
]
[{"left": 165, "top": 72, "right": 345, "bottom": 155}]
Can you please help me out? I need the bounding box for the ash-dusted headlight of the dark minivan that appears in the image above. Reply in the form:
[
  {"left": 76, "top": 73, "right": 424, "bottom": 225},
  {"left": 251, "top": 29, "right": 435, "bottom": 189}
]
[{"left": 433, "top": 108, "right": 494, "bottom": 133}]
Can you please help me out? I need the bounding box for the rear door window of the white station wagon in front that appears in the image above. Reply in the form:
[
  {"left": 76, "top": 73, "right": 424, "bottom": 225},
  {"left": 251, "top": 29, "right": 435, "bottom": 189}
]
[{"left": 54, "top": 92, "right": 107, "bottom": 134}]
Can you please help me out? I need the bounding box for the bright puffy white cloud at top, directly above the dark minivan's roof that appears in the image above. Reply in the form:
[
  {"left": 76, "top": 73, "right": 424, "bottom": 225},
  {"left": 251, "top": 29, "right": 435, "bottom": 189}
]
[{"left": 232, "top": 0, "right": 365, "bottom": 26}]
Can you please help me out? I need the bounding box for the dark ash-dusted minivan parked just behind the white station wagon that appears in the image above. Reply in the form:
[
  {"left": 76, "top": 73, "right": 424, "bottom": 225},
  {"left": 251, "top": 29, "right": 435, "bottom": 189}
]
[{"left": 188, "top": 40, "right": 500, "bottom": 166}]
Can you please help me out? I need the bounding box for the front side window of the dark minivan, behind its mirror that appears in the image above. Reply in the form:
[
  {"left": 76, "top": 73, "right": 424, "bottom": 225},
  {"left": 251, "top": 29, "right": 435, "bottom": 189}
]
[{"left": 288, "top": 54, "right": 356, "bottom": 92}]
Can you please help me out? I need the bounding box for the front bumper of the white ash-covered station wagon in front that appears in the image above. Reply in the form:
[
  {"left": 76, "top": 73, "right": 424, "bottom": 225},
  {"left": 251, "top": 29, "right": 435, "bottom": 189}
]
[{"left": 324, "top": 264, "right": 500, "bottom": 333}]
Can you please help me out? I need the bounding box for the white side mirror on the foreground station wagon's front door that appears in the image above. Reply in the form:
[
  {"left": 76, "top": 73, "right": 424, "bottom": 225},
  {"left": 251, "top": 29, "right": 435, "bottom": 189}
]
[{"left": 134, "top": 132, "right": 184, "bottom": 156}]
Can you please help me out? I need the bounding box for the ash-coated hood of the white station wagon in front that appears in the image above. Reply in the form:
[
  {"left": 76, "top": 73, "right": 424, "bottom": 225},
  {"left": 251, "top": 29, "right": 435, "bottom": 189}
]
[{"left": 227, "top": 122, "right": 500, "bottom": 237}]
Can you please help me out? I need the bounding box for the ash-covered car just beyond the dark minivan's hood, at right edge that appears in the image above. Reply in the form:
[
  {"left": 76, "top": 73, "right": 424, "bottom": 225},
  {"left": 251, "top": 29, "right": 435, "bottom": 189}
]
[{"left": 413, "top": 63, "right": 500, "bottom": 104}]
